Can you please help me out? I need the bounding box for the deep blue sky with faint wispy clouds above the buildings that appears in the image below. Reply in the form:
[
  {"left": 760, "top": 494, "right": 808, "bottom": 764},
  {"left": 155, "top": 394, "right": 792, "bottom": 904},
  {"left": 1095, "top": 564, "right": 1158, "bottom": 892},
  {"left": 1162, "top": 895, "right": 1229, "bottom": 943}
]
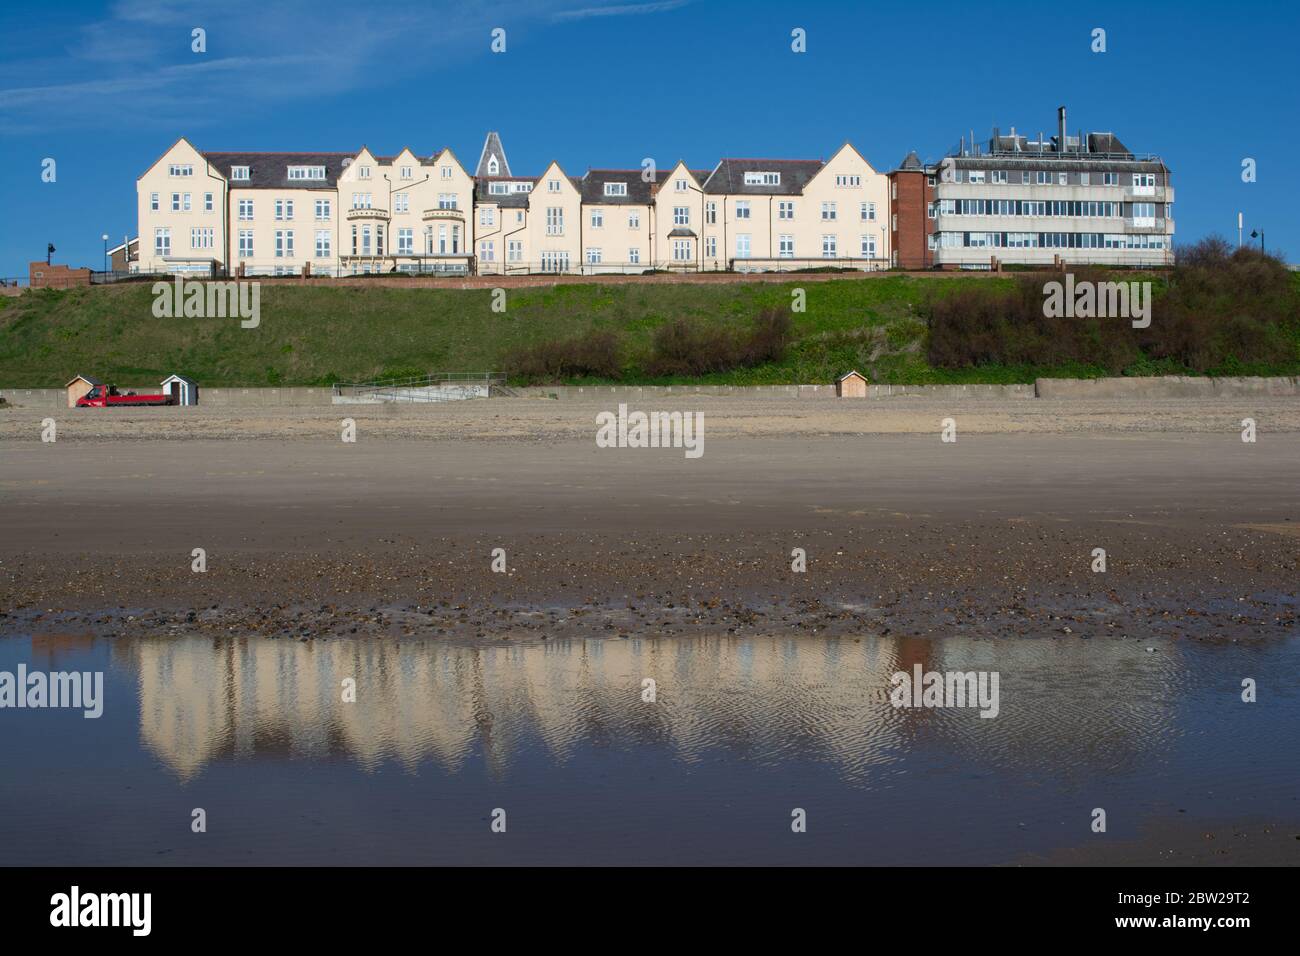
[{"left": 0, "top": 0, "right": 1300, "bottom": 276}]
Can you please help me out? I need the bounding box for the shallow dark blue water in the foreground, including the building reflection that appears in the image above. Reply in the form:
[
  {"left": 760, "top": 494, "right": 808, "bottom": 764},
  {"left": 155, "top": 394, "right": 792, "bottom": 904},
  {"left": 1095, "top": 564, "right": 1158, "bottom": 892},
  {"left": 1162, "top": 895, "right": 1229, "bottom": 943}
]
[{"left": 0, "top": 635, "right": 1300, "bottom": 865}]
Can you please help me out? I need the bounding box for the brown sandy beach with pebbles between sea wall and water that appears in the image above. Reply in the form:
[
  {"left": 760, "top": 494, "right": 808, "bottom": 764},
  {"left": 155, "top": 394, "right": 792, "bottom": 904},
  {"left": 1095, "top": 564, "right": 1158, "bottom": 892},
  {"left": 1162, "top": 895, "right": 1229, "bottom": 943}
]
[{"left": 0, "top": 395, "right": 1300, "bottom": 640}]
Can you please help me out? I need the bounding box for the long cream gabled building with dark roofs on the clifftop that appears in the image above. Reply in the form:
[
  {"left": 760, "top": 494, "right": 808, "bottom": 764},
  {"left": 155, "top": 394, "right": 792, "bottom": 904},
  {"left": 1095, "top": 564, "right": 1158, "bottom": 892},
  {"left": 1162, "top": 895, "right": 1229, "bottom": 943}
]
[{"left": 133, "top": 133, "right": 889, "bottom": 276}]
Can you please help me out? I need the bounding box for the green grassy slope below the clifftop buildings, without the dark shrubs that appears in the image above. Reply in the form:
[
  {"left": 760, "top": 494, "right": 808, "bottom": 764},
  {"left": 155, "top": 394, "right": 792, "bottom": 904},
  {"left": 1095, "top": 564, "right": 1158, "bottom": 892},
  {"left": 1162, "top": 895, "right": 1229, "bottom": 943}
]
[{"left": 0, "top": 267, "right": 1300, "bottom": 388}]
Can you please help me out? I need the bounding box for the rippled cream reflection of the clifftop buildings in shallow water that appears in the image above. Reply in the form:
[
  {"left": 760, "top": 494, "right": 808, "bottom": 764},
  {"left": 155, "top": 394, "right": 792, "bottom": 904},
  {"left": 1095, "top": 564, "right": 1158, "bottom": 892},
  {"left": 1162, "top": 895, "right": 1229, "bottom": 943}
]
[{"left": 122, "top": 637, "right": 1169, "bottom": 778}]
